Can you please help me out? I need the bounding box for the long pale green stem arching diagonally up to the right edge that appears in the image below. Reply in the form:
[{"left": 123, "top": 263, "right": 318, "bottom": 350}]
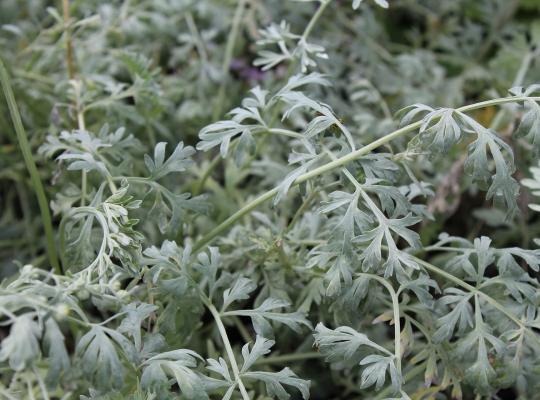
[{"left": 193, "top": 96, "right": 540, "bottom": 251}]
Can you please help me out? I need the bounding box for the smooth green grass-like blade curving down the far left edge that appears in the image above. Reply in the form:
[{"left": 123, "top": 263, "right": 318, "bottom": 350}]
[{"left": 0, "top": 59, "right": 61, "bottom": 274}]
